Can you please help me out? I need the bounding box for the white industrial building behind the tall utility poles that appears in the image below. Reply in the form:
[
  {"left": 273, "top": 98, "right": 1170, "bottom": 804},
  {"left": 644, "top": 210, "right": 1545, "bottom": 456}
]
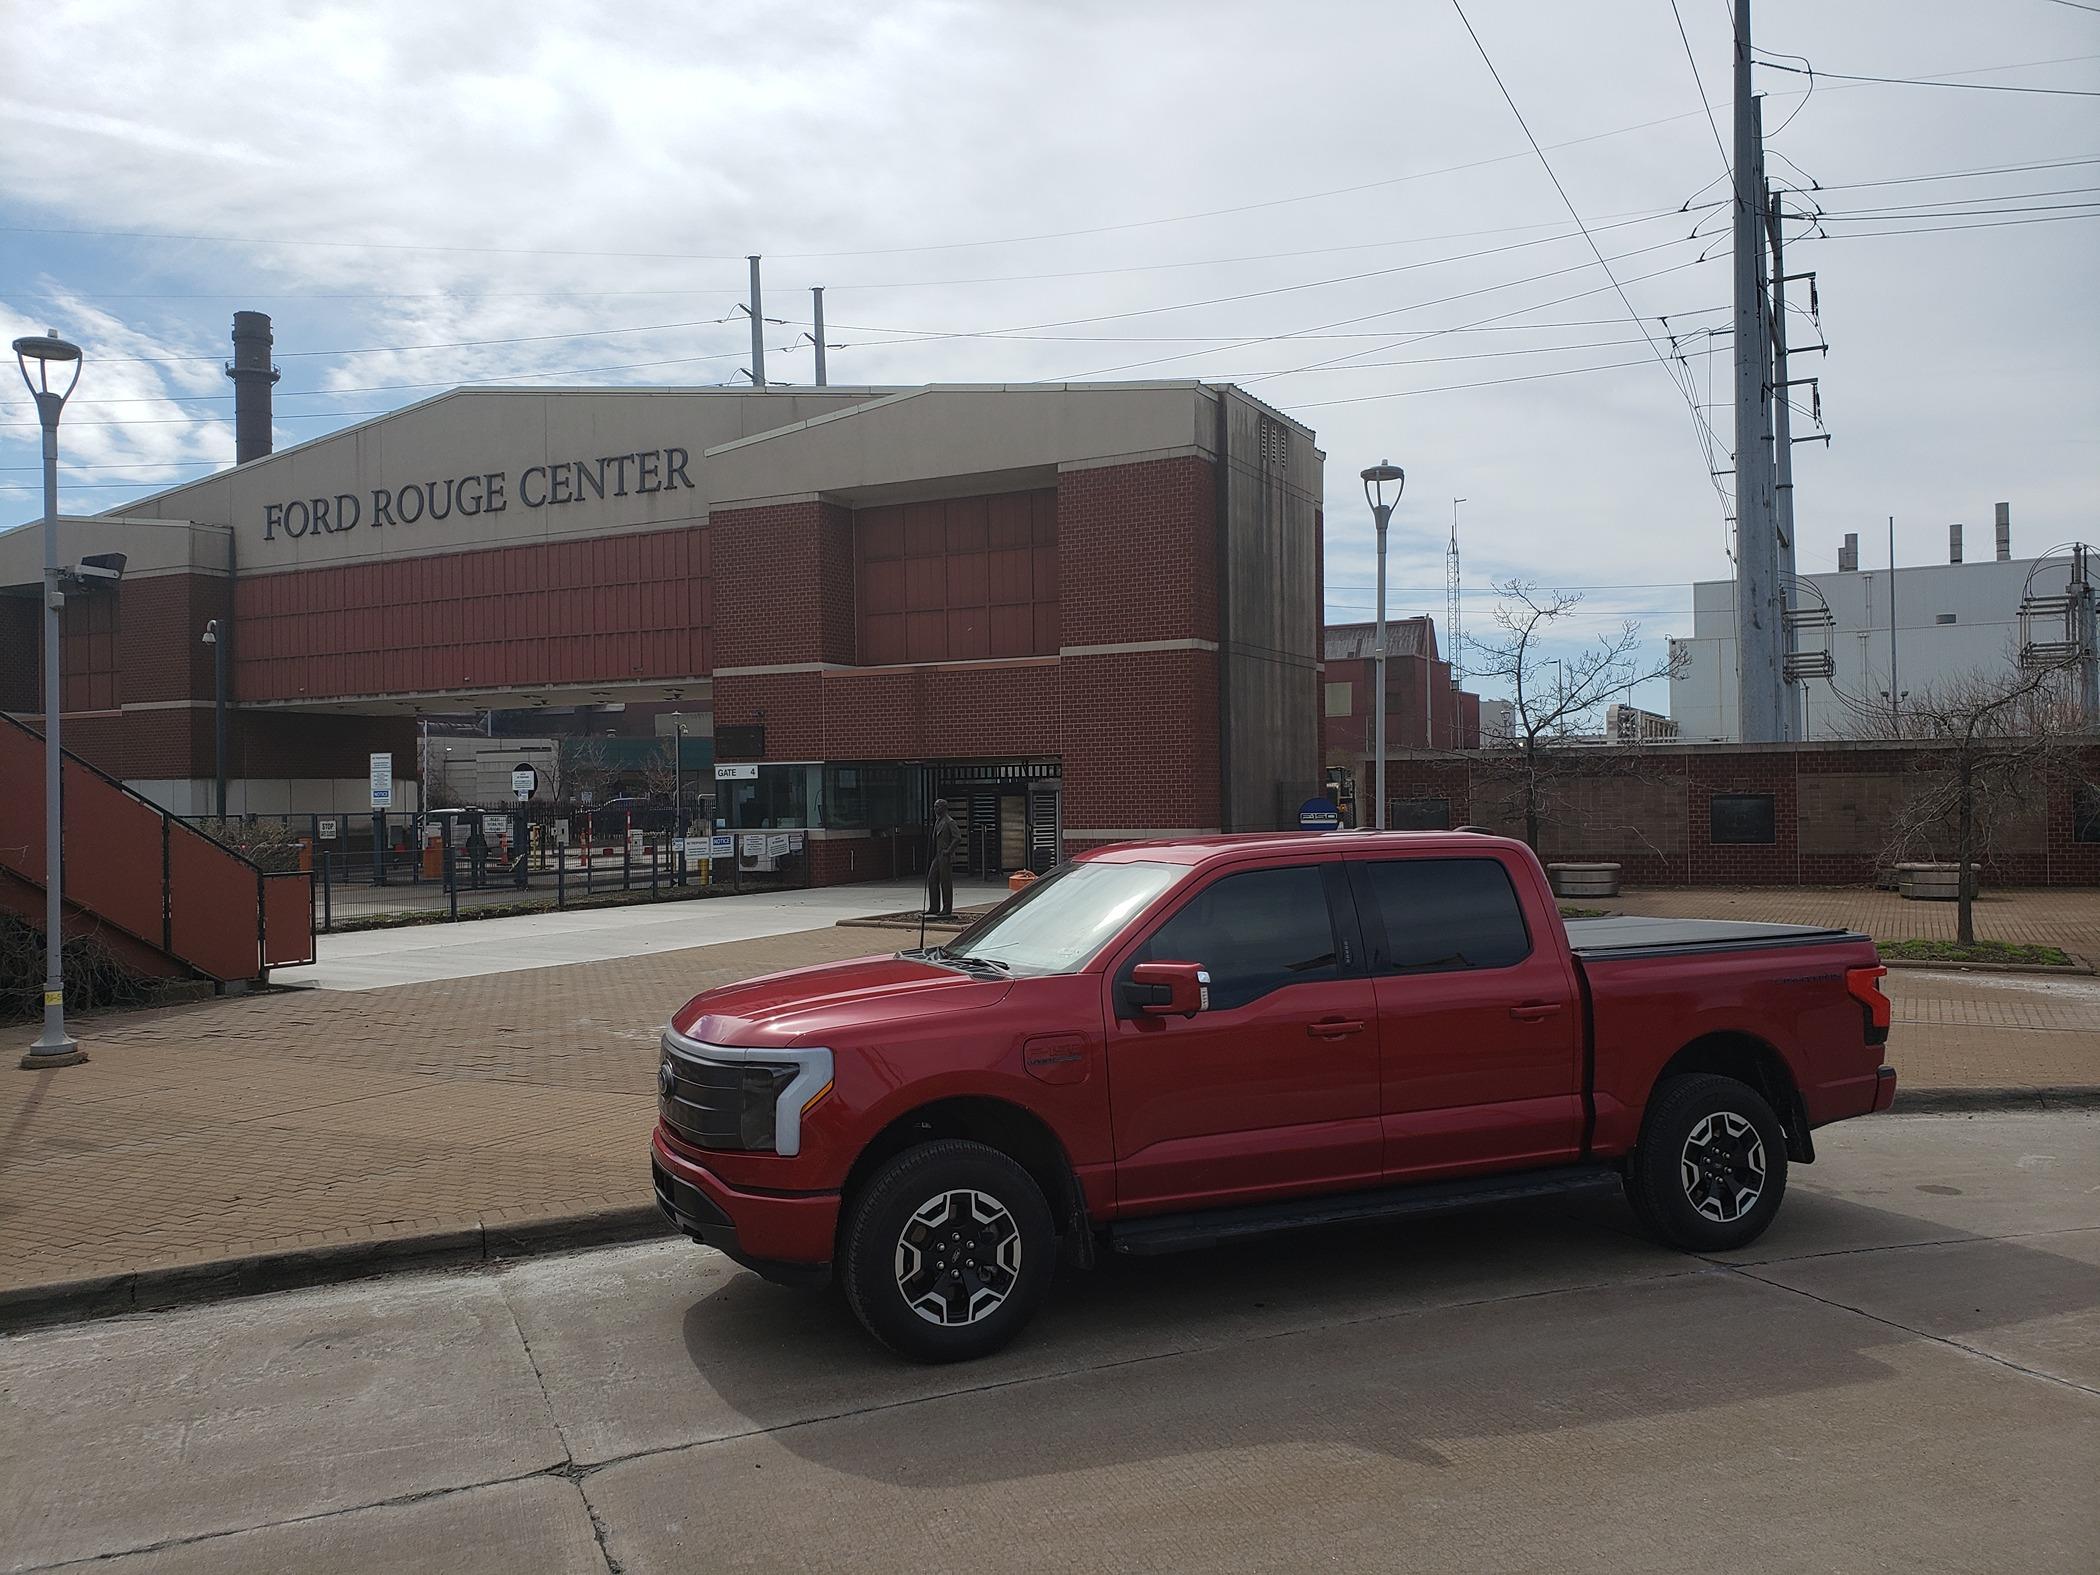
[{"left": 1670, "top": 514, "right": 2092, "bottom": 743}]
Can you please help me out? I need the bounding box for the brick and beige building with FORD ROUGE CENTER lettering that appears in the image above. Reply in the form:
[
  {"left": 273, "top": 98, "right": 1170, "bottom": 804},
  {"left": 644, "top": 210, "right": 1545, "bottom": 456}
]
[{"left": 0, "top": 382, "right": 1323, "bottom": 880}]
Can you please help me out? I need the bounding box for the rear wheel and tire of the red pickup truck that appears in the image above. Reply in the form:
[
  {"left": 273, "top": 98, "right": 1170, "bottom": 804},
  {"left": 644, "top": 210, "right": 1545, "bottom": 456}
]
[{"left": 1625, "top": 1073, "right": 1787, "bottom": 1252}]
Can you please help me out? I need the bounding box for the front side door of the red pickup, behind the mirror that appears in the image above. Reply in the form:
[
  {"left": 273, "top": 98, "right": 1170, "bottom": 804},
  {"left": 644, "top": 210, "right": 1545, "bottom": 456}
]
[{"left": 1109, "top": 859, "right": 1382, "bottom": 1214}]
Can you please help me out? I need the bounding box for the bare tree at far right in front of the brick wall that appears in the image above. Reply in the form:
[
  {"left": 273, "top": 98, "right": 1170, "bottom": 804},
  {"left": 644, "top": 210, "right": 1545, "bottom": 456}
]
[{"left": 1859, "top": 662, "right": 2092, "bottom": 945}]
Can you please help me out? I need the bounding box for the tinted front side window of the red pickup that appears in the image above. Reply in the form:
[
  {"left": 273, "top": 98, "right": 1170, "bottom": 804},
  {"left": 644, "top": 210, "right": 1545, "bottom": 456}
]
[{"left": 1134, "top": 865, "right": 1342, "bottom": 1010}]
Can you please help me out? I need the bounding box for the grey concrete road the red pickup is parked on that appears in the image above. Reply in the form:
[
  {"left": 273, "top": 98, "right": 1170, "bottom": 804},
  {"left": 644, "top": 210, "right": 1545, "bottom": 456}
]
[{"left": 0, "top": 1115, "right": 2100, "bottom": 1575}]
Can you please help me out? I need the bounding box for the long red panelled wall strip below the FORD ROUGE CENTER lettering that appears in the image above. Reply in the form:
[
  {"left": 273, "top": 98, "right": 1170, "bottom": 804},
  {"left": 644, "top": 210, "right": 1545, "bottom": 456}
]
[{"left": 227, "top": 525, "right": 705, "bottom": 699}]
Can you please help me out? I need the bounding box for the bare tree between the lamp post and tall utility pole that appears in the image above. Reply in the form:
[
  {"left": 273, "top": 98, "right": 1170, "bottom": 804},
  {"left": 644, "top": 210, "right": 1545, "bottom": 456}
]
[{"left": 1466, "top": 580, "right": 1676, "bottom": 851}]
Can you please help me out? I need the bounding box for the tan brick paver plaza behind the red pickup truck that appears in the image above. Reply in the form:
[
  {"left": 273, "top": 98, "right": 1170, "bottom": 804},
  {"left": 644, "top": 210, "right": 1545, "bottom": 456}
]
[{"left": 0, "top": 893, "right": 2100, "bottom": 1289}]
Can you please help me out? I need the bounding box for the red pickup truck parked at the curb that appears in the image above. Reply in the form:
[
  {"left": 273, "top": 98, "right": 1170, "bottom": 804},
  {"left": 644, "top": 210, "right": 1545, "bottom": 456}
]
[{"left": 651, "top": 832, "right": 1896, "bottom": 1361}]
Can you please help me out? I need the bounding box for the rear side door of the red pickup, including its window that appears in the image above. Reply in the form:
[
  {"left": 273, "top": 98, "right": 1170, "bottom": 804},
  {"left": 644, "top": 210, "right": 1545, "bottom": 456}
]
[{"left": 1348, "top": 857, "right": 1583, "bottom": 1180}]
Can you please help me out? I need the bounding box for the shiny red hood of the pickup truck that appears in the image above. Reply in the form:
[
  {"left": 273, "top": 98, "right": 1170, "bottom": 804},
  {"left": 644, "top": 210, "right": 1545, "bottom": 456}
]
[{"left": 670, "top": 956, "right": 1012, "bottom": 1048}]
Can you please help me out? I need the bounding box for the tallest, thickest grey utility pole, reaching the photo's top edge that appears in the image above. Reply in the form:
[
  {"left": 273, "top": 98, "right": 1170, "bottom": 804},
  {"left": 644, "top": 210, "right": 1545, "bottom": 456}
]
[{"left": 1735, "top": 0, "right": 1785, "bottom": 743}]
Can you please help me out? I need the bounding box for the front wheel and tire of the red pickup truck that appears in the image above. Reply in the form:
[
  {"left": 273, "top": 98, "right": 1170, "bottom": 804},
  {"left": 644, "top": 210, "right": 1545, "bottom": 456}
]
[{"left": 840, "top": 1138, "right": 1056, "bottom": 1363}]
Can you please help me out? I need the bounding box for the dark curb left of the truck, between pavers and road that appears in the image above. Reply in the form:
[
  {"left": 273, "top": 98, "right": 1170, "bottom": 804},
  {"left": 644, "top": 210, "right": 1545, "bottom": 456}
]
[{"left": 0, "top": 1203, "right": 672, "bottom": 1334}]
